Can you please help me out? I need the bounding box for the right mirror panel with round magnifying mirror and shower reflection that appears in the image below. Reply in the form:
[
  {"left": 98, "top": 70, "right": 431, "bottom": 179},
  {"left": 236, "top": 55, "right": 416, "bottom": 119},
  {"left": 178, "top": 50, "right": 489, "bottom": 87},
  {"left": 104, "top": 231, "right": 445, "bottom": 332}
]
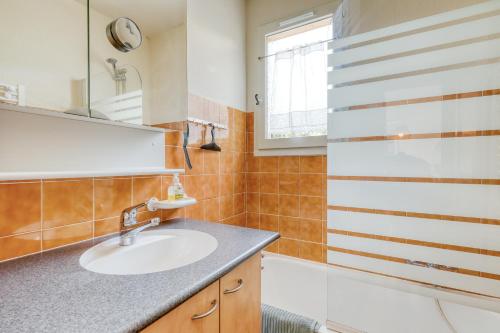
[{"left": 89, "top": 0, "right": 186, "bottom": 125}]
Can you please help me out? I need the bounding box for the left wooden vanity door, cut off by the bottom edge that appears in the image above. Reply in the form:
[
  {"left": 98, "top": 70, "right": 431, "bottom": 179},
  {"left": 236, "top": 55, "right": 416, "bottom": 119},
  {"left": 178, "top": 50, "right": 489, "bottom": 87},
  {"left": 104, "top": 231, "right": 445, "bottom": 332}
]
[{"left": 142, "top": 281, "right": 219, "bottom": 333}]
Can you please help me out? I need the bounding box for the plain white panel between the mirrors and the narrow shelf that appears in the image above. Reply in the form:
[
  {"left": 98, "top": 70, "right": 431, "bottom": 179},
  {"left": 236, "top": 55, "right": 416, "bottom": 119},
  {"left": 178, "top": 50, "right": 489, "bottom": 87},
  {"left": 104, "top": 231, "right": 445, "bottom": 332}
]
[{"left": 0, "top": 106, "right": 165, "bottom": 173}]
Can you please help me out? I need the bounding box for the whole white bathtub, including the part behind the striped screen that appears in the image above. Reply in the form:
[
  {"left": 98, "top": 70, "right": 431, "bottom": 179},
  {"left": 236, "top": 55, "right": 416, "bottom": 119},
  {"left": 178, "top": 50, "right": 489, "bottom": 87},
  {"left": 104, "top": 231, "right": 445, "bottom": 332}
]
[{"left": 262, "top": 253, "right": 500, "bottom": 333}]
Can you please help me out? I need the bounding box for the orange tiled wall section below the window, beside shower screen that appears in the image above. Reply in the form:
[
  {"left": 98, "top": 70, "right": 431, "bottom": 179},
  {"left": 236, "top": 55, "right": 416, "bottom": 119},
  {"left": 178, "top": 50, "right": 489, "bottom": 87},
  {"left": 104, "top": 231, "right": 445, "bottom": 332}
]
[{"left": 246, "top": 113, "right": 327, "bottom": 262}]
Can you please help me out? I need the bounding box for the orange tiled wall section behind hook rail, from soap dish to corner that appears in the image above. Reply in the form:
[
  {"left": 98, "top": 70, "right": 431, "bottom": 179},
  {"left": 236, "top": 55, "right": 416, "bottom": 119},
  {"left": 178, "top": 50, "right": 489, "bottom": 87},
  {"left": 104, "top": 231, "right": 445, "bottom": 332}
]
[{"left": 165, "top": 100, "right": 246, "bottom": 226}]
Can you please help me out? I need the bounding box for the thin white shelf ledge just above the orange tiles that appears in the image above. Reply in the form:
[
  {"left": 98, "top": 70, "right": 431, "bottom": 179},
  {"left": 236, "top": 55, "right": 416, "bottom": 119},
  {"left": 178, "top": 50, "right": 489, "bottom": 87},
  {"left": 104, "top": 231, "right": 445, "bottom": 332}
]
[{"left": 0, "top": 168, "right": 185, "bottom": 181}]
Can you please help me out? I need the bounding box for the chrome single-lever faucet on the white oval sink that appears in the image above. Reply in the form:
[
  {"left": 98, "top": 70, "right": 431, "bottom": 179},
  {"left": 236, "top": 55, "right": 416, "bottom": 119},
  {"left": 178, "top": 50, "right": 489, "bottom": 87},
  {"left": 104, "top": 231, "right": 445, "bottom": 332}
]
[{"left": 120, "top": 198, "right": 160, "bottom": 246}]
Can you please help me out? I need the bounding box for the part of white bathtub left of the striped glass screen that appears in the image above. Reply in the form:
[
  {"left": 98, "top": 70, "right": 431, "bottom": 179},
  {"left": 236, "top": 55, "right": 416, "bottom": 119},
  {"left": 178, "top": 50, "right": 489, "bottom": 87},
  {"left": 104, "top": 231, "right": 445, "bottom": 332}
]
[{"left": 262, "top": 252, "right": 327, "bottom": 332}]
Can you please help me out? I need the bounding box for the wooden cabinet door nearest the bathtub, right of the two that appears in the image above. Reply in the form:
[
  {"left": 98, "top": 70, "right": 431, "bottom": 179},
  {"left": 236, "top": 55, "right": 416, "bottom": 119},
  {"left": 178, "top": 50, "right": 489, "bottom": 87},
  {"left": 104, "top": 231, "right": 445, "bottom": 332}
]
[{"left": 220, "top": 253, "right": 261, "bottom": 333}]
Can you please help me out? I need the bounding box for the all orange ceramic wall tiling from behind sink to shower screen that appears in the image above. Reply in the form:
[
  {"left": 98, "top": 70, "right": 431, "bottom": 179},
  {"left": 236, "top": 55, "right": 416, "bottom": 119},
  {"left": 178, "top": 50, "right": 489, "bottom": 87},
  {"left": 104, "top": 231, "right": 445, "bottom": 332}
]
[{"left": 0, "top": 105, "right": 326, "bottom": 261}]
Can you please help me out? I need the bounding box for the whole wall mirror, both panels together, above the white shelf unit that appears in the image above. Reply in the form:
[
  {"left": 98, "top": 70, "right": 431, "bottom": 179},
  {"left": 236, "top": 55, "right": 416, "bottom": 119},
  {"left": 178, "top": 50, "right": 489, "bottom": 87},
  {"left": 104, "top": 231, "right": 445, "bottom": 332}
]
[{"left": 0, "top": 0, "right": 187, "bottom": 125}]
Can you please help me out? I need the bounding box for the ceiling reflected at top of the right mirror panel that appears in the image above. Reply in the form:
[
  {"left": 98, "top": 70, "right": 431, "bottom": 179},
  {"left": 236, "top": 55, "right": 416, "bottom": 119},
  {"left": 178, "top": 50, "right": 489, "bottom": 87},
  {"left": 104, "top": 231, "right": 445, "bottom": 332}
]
[{"left": 89, "top": 0, "right": 186, "bottom": 36}]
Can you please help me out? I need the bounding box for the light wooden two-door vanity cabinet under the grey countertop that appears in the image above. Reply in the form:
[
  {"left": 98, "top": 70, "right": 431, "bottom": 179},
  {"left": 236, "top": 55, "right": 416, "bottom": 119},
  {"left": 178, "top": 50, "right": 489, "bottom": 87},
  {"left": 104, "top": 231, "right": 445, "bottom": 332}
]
[{"left": 142, "top": 253, "right": 261, "bottom": 333}]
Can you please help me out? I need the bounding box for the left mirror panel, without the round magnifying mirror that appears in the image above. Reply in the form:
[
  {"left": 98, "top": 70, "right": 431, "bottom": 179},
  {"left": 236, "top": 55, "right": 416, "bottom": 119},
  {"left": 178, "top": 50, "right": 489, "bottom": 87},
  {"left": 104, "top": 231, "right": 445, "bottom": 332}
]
[{"left": 0, "top": 0, "right": 88, "bottom": 116}]
